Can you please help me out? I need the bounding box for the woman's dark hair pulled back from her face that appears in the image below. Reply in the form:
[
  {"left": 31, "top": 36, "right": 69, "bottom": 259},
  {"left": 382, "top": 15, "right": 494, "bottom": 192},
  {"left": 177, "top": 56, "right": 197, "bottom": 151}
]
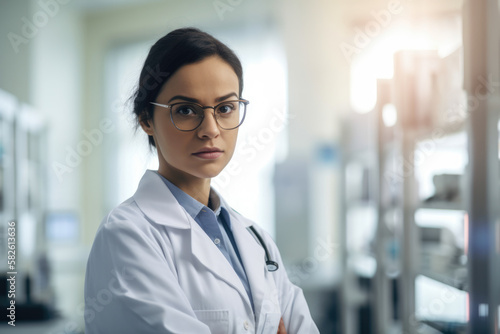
[{"left": 131, "top": 28, "right": 243, "bottom": 147}]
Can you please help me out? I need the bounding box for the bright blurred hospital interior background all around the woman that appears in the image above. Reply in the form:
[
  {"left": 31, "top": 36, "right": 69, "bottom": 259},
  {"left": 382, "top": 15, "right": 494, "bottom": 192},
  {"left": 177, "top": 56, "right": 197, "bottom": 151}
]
[{"left": 0, "top": 0, "right": 500, "bottom": 334}]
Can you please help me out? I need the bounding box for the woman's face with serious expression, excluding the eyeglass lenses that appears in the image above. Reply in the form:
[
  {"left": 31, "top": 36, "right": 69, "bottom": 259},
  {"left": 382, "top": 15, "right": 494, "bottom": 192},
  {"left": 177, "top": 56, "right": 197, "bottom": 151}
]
[{"left": 142, "top": 56, "right": 239, "bottom": 183}]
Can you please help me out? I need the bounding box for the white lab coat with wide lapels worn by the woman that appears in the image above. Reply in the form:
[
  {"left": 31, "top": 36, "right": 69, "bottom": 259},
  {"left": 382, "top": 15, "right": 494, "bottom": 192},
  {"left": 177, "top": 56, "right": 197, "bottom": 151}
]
[{"left": 84, "top": 170, "right": 319, "bottom": 334}]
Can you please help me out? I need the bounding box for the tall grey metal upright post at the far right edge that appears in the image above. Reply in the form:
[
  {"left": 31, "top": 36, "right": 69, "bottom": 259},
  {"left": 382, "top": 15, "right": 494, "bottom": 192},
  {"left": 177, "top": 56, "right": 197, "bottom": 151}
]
[{"left": 463, "top": 0, "right": 500, "bottom": 333}]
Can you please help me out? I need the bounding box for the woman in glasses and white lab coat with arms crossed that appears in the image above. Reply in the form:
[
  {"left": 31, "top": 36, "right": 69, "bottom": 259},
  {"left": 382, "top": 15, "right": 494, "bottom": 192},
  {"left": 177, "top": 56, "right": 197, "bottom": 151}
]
[{"left": 84, "top": 28, "right": 318, "bottom": 334}]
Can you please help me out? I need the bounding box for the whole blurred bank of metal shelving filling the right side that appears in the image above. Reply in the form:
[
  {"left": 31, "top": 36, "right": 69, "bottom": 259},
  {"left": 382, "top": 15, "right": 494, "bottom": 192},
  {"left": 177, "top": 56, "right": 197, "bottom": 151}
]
[{"left": 343, "top": 0, "right": 500, "bottom": 334}]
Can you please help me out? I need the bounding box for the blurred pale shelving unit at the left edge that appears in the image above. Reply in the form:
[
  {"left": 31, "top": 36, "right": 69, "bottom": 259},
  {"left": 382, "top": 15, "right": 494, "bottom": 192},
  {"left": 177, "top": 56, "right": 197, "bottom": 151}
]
[{"left": 0, "top": 90, "right": 54, "bottom": 321}]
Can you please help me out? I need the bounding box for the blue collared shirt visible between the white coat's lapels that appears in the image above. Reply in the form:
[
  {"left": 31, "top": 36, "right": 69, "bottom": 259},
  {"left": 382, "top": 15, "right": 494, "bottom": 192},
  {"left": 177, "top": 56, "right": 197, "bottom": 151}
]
[{"left": 157, "top": 172, "right": 254, "bottom": 309}]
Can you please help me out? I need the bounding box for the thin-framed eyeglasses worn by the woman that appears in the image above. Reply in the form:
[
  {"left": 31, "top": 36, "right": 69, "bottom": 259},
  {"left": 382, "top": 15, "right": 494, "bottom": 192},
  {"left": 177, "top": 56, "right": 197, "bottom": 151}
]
[{"left": 149, "top": 99, "right": 250, "bottom": 131}]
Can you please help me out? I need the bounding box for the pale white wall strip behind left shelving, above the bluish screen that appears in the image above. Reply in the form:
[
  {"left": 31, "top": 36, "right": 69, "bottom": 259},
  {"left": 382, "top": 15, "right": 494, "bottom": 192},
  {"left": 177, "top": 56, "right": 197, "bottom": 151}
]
[{"left": 30, "top": 0, "right": 83, "bottom": 224}]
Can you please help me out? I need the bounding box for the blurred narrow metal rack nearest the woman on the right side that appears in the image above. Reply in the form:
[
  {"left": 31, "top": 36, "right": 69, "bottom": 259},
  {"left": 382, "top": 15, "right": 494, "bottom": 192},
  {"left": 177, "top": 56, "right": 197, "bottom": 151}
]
[{"left": 342, "top": 80, "right": 402, "bottom": 334}]
